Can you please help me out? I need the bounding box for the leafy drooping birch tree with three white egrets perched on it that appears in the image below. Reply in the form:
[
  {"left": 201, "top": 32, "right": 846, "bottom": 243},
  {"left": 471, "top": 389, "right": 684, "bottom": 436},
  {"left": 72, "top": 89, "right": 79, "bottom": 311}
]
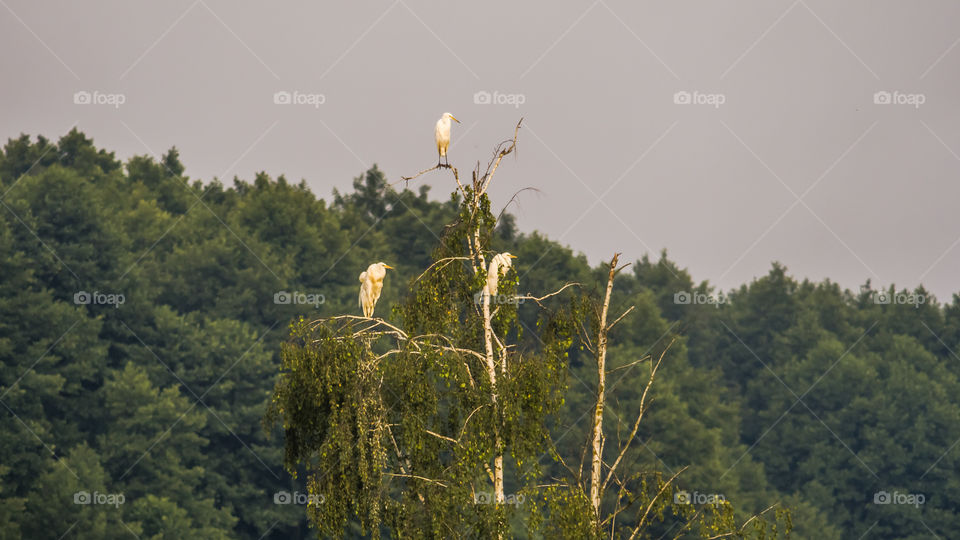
[{"left": 265, "top": 123, "right": 572, "bottom": 537}]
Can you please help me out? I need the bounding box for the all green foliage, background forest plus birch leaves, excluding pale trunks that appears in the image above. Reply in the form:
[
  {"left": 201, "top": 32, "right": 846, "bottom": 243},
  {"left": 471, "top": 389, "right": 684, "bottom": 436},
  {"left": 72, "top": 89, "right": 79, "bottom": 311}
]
[{"left": 0, "top": 130, "right": 960, "bottom": 539}]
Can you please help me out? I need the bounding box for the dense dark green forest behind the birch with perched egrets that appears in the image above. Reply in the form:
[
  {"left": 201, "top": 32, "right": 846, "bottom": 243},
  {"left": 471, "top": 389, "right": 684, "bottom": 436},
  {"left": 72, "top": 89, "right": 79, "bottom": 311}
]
[{"left": 0, "top": 130, "right": 960, "bottom": 539}]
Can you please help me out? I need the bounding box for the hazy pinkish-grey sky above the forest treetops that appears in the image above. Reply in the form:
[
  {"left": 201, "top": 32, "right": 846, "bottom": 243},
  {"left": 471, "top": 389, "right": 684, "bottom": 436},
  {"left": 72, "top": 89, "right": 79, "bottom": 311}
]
[{"left": 0, "top": 0, "right": 960, "bottom": 300}]
